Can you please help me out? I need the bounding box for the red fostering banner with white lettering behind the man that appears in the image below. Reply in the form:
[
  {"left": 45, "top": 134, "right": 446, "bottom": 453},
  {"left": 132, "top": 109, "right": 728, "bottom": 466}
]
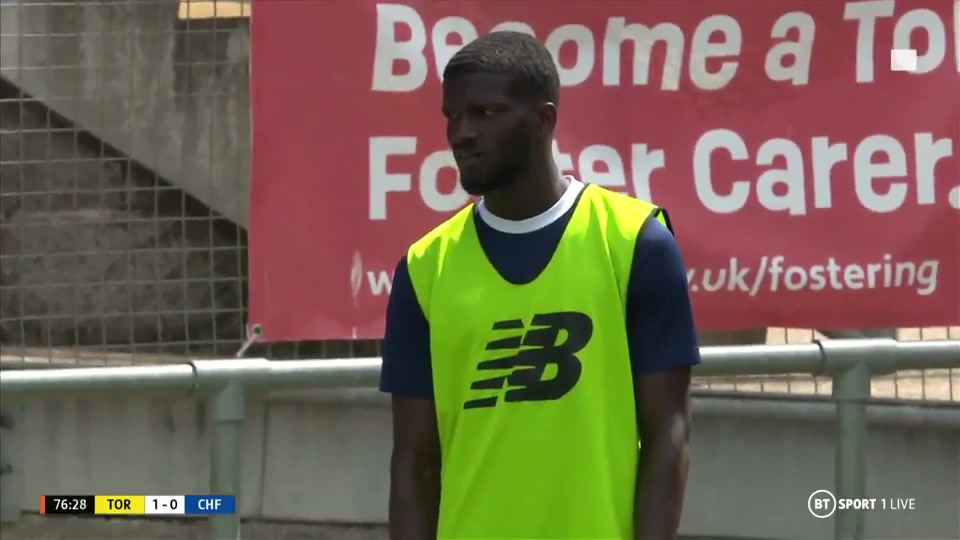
[{"left": 249, "top": 0, "right": 960, "bottom": 341}]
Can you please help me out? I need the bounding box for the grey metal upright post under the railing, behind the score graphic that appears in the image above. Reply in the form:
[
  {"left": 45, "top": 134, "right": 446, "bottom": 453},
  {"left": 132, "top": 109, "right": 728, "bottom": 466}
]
[{"left": 210, "top": 381, "right": 244, "bottom": 540}]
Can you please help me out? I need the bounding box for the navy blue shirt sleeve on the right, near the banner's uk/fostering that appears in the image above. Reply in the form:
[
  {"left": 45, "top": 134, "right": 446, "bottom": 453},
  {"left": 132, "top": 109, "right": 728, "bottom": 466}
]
[{"left": 626, "top": 218, "right": 700, "bottom": 376}]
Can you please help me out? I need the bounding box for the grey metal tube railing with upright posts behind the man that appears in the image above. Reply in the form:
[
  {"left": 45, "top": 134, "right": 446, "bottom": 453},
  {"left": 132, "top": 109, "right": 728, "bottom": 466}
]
[{"left": 0, "top": 339, "right": 960, "bottom": 540}]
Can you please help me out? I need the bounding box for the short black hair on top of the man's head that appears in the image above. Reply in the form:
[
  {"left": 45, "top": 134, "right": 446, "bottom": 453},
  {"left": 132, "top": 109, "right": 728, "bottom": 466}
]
[{"left": 443, "top": 31, "right": 560, "bottom": 105}]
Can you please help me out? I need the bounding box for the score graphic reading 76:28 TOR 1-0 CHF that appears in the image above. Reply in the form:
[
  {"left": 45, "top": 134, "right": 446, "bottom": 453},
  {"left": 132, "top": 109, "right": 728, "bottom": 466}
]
[{"left": 40, "top": 495, "right": 236, "bottom": 516}]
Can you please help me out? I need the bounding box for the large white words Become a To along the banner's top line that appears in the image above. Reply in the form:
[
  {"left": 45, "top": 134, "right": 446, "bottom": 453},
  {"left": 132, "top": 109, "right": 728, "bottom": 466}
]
[{"left": 371, "top": 0, "right": 960, "bottom": 92}]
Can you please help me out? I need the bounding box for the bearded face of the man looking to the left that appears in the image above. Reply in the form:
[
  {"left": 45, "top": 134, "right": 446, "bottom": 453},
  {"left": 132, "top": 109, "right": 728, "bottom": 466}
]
[{"left": 443, "top": 73, "right": 538, "bottom": 195}]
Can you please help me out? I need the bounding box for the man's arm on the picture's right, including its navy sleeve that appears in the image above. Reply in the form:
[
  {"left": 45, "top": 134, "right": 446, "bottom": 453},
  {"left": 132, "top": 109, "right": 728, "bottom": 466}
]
[{"left": 627, "top": 219, "right": 700, "bottom": 540}]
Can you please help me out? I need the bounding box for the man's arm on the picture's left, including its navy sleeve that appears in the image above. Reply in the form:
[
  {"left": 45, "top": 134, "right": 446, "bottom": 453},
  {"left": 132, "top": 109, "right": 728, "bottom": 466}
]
[{"left": 380, "top": 255, "right": 440, "bottom": 540}]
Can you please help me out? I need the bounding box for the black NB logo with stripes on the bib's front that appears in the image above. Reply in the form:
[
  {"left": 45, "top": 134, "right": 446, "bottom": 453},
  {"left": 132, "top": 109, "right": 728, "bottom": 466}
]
[{"left": 463, "top": 311, "right": 593, "bottom": 409}]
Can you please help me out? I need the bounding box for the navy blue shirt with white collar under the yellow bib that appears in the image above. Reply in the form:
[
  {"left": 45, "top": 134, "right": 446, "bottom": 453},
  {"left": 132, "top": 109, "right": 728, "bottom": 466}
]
[{"left": 380, "top": 184, "right": 700, "bottom": 399}]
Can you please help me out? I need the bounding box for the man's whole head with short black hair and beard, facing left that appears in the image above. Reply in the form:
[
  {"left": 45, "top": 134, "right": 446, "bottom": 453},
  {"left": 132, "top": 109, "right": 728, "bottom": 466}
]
[{"left": 443, "top": 32, "right": 560, "bottom": 195}]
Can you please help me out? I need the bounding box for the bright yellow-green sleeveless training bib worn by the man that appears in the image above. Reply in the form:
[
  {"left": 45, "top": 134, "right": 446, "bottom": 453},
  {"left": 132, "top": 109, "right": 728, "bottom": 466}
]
[{"left": 407, "top": 185, "right": 665, "bottom": 540}]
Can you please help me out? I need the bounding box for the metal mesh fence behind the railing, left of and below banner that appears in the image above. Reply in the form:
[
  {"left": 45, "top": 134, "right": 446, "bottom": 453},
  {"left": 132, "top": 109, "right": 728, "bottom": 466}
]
[{"left": 0, "top": 0, "right": 960, "bottom": 401}]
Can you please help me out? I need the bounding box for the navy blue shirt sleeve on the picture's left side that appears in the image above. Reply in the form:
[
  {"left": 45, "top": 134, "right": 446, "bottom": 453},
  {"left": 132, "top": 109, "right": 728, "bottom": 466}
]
[{"left": 380, "top": 257, "right": 433, "bottom": 399}]
